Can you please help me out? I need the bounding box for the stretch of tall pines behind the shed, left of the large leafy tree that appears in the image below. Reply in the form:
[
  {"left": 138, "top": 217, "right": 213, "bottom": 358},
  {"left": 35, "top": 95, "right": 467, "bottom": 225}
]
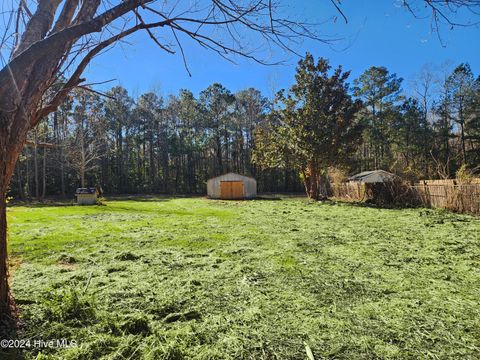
[{"left": 11, "top": 84, "right": 301, "bottom": 199}]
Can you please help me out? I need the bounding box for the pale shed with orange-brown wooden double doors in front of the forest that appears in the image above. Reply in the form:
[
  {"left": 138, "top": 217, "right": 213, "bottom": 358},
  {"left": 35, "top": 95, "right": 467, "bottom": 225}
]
[{"left": 207, "top": 172, "right": 257, "bottom": 200}]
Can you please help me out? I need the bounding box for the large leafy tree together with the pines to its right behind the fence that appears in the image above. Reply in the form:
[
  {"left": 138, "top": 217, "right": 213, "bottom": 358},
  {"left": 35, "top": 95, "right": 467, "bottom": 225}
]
[{"left": 254, "top": 54, "right": 480, "bottom": 199}]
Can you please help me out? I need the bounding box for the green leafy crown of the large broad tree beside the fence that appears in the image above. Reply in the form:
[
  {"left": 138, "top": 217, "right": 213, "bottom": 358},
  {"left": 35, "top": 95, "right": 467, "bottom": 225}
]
[{"left": 254, "top": 53, "right": 362, "bottom": 195}]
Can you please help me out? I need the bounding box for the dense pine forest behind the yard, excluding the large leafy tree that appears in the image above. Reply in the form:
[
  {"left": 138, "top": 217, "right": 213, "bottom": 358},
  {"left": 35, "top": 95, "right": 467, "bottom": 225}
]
[{"left": 10, "top": 63, "right": 480, "bottom": 199}]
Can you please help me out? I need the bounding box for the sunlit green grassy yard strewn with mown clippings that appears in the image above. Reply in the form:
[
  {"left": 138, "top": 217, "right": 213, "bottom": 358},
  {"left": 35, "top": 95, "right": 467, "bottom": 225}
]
[{"left": 0, "top": 197, "right": 480, "bottom": 360}]
